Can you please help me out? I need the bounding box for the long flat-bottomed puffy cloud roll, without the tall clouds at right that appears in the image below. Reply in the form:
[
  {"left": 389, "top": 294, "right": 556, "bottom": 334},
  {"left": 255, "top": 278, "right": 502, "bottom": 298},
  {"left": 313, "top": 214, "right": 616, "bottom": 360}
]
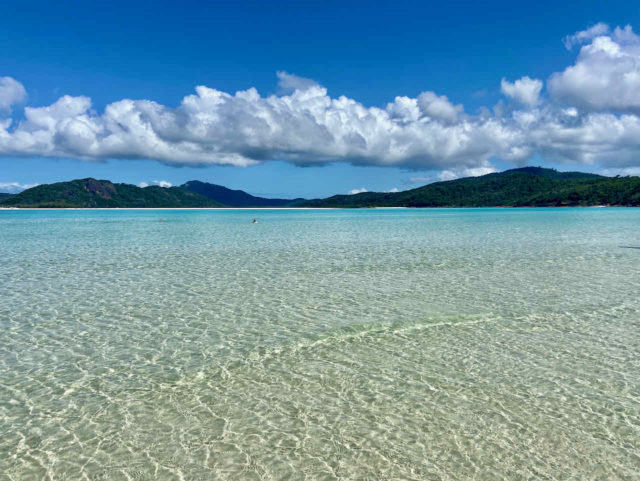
[{"left": 0, "top": 78, "right": 528, "bottom": 168}]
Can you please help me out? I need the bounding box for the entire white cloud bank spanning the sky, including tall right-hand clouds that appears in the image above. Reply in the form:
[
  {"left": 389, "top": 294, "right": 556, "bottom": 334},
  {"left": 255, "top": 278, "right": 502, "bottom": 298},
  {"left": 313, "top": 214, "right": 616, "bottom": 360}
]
[{"left": 0, "top": 24, "right": 640, "bottom": 174}]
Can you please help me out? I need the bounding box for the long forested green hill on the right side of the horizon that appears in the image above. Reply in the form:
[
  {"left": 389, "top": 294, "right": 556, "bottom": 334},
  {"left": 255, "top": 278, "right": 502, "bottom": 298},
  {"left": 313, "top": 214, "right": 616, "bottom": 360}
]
[{"left": 301, "top": 167, "right": 640, "bottom": 207}]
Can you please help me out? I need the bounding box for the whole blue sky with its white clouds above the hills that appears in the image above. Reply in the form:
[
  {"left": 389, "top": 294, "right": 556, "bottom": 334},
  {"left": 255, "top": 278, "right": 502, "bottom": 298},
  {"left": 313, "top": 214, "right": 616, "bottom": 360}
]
[{"left": 0, "top": 0, "right": 640, "bottom": 198}]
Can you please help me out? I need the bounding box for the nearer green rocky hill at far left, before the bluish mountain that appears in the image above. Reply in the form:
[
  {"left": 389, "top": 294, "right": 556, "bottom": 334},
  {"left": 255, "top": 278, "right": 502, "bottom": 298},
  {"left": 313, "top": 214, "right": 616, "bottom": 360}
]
[{"left": 0, "top": 178, "right": 221, "bottom": 207}]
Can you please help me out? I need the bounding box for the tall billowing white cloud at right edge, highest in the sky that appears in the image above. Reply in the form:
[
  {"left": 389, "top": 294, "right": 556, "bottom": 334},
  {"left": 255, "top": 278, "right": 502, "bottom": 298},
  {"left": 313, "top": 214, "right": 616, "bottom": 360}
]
[{"left": 548, "top": 26, "right": 640, "bottom": 113}]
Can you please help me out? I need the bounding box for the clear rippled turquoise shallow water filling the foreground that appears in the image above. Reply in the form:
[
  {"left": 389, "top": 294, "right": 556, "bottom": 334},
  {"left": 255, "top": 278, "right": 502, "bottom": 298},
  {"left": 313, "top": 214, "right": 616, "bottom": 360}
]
[{"left": 0, "top": 208, "right": 640, "bottom": 481}]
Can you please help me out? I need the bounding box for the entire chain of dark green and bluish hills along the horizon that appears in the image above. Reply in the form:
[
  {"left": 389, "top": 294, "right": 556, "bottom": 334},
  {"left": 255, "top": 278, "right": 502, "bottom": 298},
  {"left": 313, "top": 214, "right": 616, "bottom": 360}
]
[{"left": 0, "top": 167, "right": 640, "bottom": 208}]
